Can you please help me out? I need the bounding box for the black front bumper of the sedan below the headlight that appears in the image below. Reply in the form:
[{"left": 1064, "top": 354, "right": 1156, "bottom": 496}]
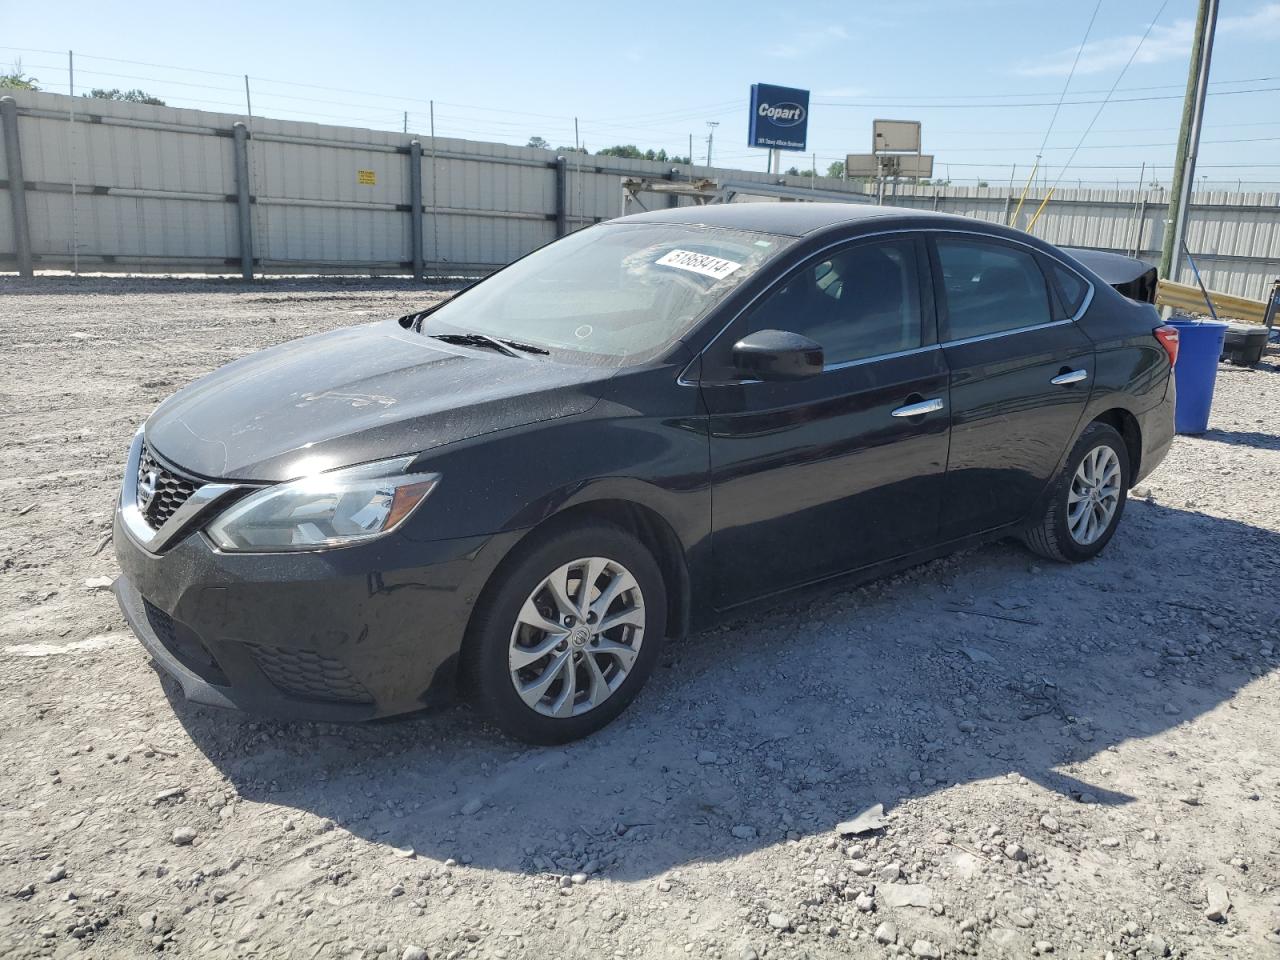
[{"left": 114, "top": 478, "right": 503, "bottom": 719}]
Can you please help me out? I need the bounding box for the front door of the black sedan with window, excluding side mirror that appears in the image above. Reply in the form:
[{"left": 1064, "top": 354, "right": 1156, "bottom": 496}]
[{"left": 701, "top": 236, "right": 948, "bottom": 608}]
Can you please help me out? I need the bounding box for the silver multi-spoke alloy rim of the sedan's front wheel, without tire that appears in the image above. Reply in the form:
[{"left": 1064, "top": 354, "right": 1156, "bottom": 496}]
[{"left": 508, "top": 557, "right": 645, "bottom": 717}]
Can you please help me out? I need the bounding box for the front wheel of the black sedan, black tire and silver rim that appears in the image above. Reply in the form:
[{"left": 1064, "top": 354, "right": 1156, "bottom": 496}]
[{"left": 465, "top": 521, "right": 667, "bottom": 744}]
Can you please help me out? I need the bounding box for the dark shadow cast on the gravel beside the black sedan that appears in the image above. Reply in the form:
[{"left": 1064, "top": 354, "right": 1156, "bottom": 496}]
[{"left": 165, "top": 500, "right": 1280, "bottom": 879}]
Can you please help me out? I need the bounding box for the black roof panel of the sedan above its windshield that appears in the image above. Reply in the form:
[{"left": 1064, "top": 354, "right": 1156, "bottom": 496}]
[{"left": 612, "top": 201, "right": 991, "bottom": 237}]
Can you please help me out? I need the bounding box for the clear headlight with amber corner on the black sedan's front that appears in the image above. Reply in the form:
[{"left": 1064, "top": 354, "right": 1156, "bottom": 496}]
[{"left": 209, "top": 457, "right": 440, "bottom": 553}]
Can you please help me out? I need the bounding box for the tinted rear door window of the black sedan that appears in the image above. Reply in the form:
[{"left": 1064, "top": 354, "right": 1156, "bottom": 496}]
[{"left": 937, "top": 237, "right": 1053, "bottom": 340}]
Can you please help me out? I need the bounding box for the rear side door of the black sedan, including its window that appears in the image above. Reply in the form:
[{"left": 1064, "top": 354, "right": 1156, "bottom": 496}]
[{"left": 931, "top": 232, "right": 1093, "bottom": 540}]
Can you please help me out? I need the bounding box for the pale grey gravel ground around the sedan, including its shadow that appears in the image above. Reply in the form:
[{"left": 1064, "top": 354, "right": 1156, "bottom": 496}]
[{"left": 0, "top": 273, "right": 1280, "bottom": 960}]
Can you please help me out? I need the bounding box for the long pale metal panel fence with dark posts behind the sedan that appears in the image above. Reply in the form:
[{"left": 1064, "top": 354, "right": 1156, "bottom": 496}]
[{"left": 0, "top": 91, "right": 1280, "bottom": 298}]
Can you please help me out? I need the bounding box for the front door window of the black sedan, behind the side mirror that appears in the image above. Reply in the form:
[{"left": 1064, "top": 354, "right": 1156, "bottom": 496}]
[{"left": 739, "top": 239, "right": 922, "bottom": 366}]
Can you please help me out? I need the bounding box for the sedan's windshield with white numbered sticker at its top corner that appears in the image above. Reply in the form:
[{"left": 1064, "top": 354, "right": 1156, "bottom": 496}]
[{"left": 422, "top": 223, "right": 792, "bottom": 365}]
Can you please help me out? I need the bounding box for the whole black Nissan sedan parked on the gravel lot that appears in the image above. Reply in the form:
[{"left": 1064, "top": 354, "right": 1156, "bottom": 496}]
[{"left": 115, "top": 204, "right": 1178, "bottom": 742}]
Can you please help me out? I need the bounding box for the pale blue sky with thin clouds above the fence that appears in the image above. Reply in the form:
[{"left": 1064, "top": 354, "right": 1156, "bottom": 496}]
[{"left": 0, "top": 0, "right": 1280, "bottom": 189}]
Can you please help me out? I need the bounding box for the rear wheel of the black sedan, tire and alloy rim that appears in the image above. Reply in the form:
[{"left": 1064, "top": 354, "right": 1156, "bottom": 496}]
[{"left": 1023, "top": 421, "right": 1130, "bottom": 563}]
